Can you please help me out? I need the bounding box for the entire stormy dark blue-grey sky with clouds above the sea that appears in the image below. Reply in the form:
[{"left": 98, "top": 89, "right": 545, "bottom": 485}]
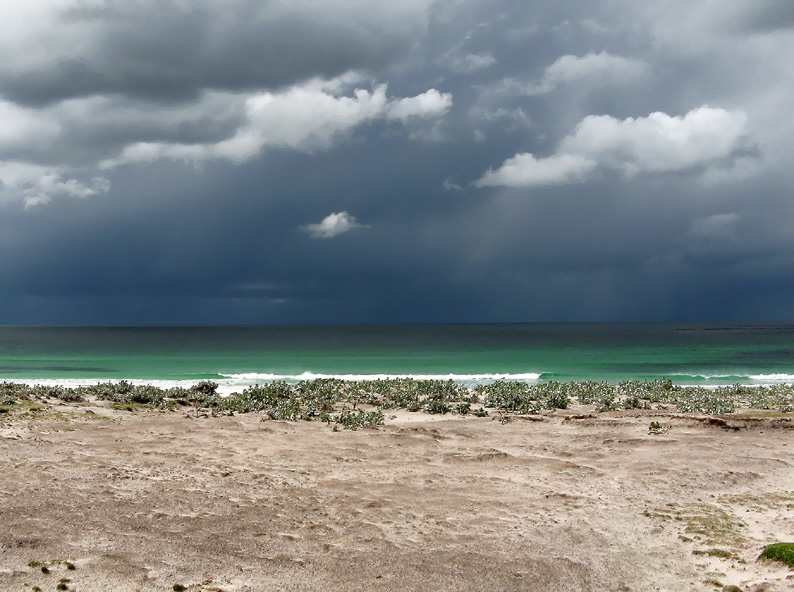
[{"left": 0, "top": 0, "right": 794, "bottom": 324}]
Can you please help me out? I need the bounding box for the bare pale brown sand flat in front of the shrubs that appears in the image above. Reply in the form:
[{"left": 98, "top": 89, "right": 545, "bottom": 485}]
[{"left": 0, "top": 404, "right": 794, "bottom": 592}]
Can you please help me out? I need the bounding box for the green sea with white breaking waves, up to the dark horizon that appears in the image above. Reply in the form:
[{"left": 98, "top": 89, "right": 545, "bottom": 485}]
[{"left": 0, "top": 323, "right": 794, "bottom": 392}]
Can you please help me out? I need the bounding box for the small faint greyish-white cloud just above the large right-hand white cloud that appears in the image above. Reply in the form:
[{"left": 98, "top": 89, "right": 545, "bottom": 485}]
[{"left": 530, "top": 52, "right": 647, "bottom": 94}]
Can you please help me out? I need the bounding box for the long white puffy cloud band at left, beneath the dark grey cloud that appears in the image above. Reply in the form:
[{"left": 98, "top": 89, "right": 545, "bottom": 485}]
[{"left": 0, "top": 73, "right": 452, "bottom": 207}]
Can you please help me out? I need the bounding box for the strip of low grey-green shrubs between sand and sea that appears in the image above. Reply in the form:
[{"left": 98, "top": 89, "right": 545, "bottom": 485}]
[{"left": 0, "top": 378, "right": 794, "bottom": 431}]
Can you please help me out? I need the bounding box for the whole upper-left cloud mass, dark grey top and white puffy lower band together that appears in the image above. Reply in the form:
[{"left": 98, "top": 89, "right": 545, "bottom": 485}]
[{"left": 0, "top": 0, "right": 451, "bottom": 207}]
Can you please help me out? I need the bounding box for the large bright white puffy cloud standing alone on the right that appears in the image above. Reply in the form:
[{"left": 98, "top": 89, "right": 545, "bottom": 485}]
[{"left": 476, "top": 106, "right": 747, "bottom": 187}]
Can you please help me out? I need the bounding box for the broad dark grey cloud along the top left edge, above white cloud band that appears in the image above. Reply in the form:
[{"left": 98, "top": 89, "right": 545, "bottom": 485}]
[{"left": 0, "top": 0, "right": 425, "bottom": 105}]
